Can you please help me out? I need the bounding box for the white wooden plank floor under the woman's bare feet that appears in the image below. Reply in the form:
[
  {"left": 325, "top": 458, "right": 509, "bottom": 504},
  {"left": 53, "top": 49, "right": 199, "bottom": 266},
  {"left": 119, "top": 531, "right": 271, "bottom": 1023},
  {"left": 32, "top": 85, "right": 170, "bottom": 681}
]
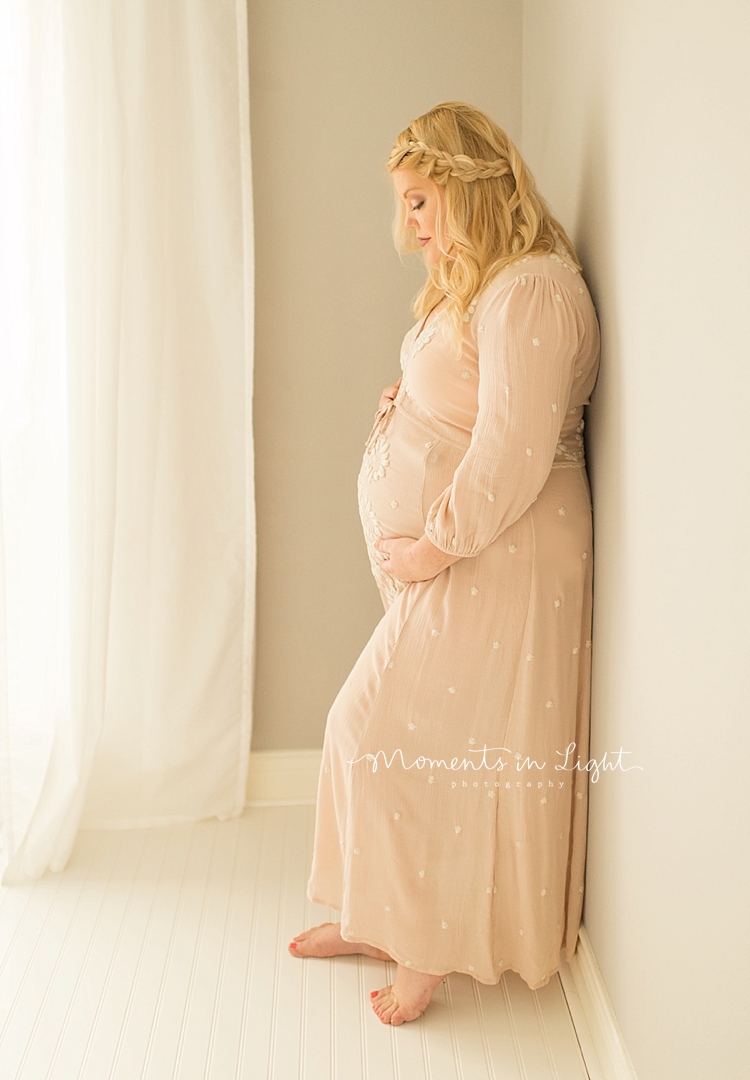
[{"left": 0, "top": 806, "right": 588, "bottom": 1080}]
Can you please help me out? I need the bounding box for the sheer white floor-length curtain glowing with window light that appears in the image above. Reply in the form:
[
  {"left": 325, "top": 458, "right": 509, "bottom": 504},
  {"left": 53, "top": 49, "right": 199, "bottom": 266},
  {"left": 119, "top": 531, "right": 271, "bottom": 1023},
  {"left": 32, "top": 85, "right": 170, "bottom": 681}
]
[{"left": 0, "top": 0, "right": 255, "bottom": 885}]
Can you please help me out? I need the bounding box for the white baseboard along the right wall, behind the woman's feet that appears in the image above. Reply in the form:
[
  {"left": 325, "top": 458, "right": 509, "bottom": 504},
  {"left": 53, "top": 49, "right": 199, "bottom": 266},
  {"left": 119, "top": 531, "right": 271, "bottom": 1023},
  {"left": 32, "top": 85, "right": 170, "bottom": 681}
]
[{"left": 560, "top": 924, "right": 638, "bottom": 1080}]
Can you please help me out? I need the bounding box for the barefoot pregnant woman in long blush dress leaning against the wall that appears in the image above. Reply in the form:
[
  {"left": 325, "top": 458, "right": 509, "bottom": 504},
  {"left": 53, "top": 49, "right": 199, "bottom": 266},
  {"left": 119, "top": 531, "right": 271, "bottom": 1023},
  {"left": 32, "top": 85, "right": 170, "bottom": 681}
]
[{"left": 290, "top": 103, "right": 599, "bottom": 1025}]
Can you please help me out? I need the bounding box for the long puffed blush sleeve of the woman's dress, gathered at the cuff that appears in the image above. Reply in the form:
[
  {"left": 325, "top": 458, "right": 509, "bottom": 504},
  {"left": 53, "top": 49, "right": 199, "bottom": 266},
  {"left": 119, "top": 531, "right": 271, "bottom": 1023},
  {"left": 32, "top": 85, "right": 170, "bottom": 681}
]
[{"left": 425, "top": 274, "right": 584, "bottom": 556}]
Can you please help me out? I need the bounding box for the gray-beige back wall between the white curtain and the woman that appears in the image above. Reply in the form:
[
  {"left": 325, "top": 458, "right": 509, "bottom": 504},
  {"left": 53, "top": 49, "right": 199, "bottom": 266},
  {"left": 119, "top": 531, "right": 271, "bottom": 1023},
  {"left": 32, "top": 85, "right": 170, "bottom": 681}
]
[{"left": 249, "top": 0, "right": 521, "bottom": 751}]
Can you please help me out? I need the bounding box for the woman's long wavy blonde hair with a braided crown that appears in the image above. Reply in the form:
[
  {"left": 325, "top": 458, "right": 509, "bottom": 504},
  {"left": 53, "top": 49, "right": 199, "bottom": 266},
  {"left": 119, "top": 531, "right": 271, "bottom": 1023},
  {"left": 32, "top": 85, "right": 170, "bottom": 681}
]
[{"left": 388, "top": 102, "right": 581, "bottom": 334}]
